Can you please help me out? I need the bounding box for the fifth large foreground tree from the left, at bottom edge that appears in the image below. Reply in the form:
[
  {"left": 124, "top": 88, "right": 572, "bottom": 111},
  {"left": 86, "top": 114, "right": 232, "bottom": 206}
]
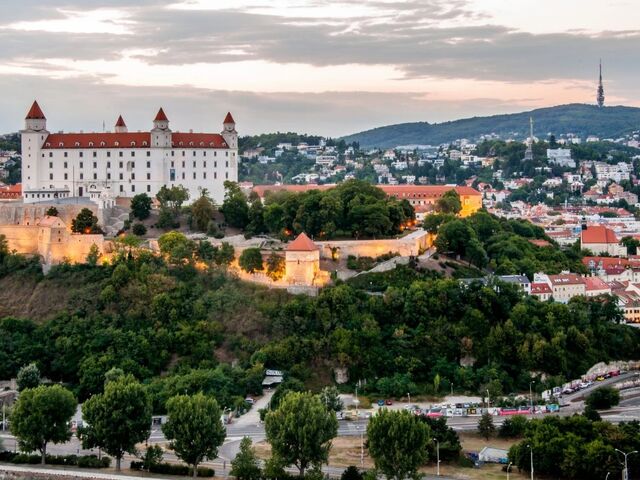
[{"left": 367, "top": 409, "right": 431, "bottom": 480}]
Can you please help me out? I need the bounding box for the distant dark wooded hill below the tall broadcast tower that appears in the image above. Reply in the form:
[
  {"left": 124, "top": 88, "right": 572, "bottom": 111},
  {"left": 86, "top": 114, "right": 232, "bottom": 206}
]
[{"left": 343, "top": 103, "right": 640, "bottom": 148}]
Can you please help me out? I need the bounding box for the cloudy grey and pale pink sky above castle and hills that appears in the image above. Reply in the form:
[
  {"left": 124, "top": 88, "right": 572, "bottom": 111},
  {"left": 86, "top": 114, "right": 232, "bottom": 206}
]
[{"left": 0, "top": 0, "right": 640, "bottom": 136}]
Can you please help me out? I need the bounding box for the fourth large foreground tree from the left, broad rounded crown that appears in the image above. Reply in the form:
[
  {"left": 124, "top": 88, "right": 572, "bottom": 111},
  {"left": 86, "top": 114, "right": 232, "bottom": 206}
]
[{"left": 265, "top": 392, "right": 338, "bottom": 477}]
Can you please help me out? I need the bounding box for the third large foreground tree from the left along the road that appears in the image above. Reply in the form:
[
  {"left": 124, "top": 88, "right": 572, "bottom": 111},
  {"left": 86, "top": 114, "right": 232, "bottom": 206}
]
[{"left": 162, "top": 393, "right": 226, "bottom": 477}]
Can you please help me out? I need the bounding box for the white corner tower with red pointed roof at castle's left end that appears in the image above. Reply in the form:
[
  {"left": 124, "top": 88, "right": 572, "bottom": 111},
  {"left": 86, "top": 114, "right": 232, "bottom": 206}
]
[{"left": 20, "top": 101, "right": 49, "bottom": 191}]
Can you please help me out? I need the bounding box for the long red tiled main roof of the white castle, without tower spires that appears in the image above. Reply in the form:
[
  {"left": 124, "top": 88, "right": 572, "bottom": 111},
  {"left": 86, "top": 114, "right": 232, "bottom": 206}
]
[{"left": 42, "top": 132, "right": 228, "bottom": 150}]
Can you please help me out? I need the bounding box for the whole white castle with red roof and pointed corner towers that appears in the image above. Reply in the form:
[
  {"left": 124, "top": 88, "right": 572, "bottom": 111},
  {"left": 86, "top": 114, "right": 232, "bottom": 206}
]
[{"left": 20, "top": 102, "right": 238, "bottom": 203}]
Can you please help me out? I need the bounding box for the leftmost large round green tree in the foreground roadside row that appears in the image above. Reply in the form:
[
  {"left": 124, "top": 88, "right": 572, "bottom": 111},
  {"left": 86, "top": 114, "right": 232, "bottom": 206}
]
[{"left": 10, "top": 385, "right": 77, "bottom": 465}]
